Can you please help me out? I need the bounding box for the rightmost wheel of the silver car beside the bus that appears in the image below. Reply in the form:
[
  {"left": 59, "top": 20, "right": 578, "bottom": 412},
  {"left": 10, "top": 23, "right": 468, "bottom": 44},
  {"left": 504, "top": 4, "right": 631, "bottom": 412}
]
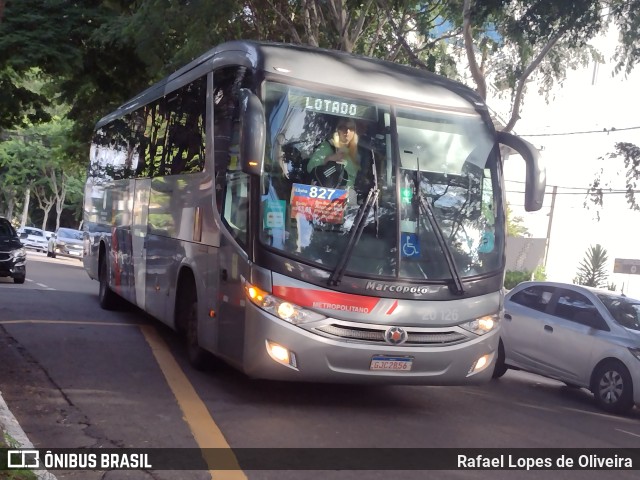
[{"left": 591, "top": 361, "right": 633, "bottom": 413}]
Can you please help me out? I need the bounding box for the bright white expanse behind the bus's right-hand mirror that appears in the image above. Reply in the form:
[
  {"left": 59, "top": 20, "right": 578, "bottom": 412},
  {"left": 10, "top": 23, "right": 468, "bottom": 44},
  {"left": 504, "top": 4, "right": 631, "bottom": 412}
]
[{"left": 498, "top": 28, "right": 640, "bottom": 298}]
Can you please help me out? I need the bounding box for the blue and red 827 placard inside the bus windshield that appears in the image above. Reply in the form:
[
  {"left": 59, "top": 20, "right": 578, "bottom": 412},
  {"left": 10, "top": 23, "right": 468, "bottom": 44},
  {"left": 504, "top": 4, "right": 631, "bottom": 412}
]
[{"left": 291, "top": 183, "right": 349, "bottom": 224}]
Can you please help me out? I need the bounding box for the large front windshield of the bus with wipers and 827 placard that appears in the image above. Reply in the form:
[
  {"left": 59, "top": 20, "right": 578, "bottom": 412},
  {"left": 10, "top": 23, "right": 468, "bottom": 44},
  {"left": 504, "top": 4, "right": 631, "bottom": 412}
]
[{"left": 260, "top": 82, "right": 504, "bottom": 282}]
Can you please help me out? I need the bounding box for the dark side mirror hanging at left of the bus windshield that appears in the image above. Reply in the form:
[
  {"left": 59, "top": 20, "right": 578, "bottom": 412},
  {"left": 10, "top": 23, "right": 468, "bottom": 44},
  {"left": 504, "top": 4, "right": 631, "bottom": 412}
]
[{"left": 240, "top": 88, "right": 266, "bottom": 175}]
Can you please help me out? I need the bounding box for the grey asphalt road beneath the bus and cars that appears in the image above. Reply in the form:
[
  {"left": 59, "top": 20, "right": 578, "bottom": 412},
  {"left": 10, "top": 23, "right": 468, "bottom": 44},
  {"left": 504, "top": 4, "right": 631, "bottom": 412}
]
[{"left": 0, "top": 252, "right": 640, "bottom": 480}]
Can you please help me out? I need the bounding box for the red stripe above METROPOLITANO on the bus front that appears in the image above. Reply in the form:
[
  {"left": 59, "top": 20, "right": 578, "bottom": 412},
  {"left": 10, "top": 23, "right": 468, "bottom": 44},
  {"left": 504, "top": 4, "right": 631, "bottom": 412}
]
[{"left": 273, "top": 285, "right": 380, "bottom": 313}]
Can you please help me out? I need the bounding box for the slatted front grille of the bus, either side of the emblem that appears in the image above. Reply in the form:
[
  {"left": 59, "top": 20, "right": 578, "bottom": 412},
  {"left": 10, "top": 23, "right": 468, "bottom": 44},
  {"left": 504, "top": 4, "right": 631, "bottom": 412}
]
[{"left": 314, "top": 325, "right": 468, "bottom": 345}]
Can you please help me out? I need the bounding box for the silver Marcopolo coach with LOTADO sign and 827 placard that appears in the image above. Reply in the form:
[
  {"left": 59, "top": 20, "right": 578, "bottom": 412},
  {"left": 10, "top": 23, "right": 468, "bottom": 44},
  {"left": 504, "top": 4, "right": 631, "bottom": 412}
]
[{"left": 83, "top": 41, "right": 545, "bottom": 385}]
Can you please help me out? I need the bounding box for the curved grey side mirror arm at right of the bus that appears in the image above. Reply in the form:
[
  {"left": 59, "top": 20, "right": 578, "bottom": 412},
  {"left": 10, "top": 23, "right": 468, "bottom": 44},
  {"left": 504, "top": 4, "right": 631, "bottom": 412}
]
[{"left": 497, "top": 132, "right": 547, "bottom": 212}]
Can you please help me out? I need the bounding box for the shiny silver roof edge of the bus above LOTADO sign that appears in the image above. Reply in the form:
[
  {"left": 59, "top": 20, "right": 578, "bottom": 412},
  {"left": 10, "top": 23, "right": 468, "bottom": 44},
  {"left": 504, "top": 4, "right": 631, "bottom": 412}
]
[{"left": 97, "top": 40, "right": 488, "bottom": 128}]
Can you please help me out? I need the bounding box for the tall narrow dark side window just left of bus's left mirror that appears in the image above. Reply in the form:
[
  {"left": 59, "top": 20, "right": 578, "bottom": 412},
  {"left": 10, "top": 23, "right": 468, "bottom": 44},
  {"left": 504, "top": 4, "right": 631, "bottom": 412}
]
[{"left": 213, "top": 68, "right": 249, "bottom": 246}]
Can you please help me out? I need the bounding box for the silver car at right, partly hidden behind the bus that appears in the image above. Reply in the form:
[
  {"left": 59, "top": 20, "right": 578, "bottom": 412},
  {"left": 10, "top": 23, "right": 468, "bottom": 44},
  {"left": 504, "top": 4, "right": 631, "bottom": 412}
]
[{"left": 494, "top": 282, "right": 640, "bottom": 413}]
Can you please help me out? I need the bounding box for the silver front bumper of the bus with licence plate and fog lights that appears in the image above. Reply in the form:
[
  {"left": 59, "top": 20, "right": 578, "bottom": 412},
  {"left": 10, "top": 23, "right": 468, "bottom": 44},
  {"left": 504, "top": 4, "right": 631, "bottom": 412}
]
[{"left": 243, "top": 305, "right": 499, "bottom": 385}]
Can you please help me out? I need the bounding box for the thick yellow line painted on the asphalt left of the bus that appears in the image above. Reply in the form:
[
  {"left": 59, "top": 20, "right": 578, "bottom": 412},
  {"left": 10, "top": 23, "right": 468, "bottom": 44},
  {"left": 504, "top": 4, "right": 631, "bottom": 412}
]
[{"left": 140, "top": 325, "right": 247, "bottom": 480}]
